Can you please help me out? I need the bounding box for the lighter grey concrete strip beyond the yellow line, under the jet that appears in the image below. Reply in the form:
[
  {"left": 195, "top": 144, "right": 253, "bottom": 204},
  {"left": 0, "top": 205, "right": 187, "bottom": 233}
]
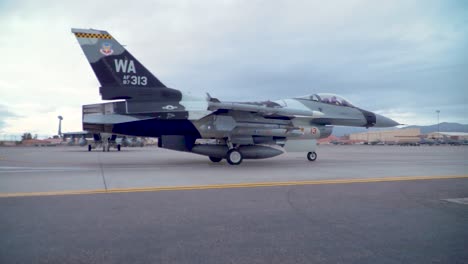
[{"left": 0, "top": 143, "right": 468, "bottom": 196}]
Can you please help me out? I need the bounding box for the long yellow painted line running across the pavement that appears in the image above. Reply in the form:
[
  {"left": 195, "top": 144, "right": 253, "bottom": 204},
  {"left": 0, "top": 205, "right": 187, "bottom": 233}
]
[{"left": 0, "top": 175, "right": 468, "bottom": 198}]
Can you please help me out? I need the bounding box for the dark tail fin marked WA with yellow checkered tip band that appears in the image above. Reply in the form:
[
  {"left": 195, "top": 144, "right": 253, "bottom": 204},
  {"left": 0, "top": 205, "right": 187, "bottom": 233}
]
[{"left": 72, "top": 28, "right": 181, "bottom": 100}]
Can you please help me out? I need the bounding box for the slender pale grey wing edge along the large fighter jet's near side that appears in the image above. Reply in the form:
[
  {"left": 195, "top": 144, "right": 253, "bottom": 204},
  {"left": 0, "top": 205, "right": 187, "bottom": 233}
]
[{"left": 208, "top": 99, "right": 323, "bottom": 118}]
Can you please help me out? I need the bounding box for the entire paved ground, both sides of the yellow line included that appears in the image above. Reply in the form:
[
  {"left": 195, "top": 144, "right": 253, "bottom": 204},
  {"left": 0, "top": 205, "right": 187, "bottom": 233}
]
[{"left": 0, "top": 146, "right": 468, "bottom": 263}]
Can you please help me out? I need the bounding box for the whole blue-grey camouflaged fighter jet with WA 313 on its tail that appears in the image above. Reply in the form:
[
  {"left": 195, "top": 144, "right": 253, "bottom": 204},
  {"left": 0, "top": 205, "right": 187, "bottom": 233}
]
[{"left": 72, "top": 29, "right": 398, "bottom": 165}]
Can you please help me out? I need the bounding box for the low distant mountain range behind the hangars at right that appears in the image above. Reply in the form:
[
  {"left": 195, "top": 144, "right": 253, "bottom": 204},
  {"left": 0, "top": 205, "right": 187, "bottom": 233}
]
[{"left": 333, "top": 122, "right": 468, "bottom": 137}]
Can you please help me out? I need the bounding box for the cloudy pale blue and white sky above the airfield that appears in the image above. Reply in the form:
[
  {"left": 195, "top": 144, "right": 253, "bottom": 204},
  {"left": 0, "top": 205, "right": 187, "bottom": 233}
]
[{"left": 0, "top": 0, "right": 468, "bottom": 140}]
